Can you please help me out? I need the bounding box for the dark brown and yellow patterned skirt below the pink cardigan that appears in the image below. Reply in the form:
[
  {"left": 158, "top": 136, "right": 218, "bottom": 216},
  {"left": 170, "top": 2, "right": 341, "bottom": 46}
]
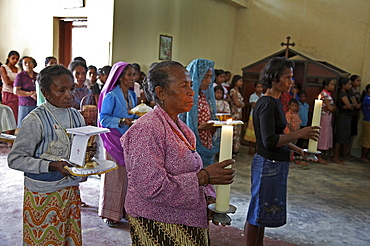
[{"left": 128, "top": 216, "right": 209, "bottom": 246}]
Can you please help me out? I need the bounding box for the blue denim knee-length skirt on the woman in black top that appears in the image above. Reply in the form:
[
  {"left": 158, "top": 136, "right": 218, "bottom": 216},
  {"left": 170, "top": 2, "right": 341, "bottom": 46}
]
[{"left": 247, "top": 154, "right": 289, "bottom": 227}]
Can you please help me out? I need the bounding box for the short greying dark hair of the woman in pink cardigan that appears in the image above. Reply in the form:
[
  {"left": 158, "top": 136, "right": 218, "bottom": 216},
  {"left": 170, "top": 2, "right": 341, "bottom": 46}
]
[{"left": 143, "top": 61, "right": 185, "bottom": 103}]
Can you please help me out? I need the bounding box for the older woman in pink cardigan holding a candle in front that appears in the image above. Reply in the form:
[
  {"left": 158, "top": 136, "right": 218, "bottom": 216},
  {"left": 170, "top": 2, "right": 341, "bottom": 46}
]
[{"left": 121, "top": 61, "right": 234, "bottom": 245}]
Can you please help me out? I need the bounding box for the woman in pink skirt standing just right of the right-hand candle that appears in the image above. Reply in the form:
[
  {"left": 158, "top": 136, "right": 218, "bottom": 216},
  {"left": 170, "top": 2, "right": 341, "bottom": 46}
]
[{"left": 317, "top": 79, "right": 337, "bottom": 164}]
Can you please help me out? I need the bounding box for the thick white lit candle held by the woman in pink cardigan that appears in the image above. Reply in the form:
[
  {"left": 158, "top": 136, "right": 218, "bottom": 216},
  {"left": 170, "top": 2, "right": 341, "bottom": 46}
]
[{"left": 216, "top": 119, "right": 233, "bottom": 212}]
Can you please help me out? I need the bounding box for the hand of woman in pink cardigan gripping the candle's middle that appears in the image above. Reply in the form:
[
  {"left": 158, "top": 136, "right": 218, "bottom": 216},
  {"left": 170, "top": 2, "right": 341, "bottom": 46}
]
[{"left": 197, "top": 159, "right": 235, "bottom": 185}]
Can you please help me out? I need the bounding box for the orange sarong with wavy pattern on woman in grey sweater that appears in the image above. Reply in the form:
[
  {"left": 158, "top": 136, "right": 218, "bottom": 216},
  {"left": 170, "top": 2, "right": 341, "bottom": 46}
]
[{"left": 23, "top": 186, "right": 82, "bottom": 246}]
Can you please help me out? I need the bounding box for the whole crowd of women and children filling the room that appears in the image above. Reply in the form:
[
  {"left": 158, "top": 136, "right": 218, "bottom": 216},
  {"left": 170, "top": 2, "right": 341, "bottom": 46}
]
[{"left": 1, "top": 51, "right": 370, "bottom": 245}]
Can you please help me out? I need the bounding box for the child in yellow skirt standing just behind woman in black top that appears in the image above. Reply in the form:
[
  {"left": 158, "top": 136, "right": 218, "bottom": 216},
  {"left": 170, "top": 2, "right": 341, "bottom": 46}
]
[{"left": 244, "top": 81, "right": 263, "bottom": 155}]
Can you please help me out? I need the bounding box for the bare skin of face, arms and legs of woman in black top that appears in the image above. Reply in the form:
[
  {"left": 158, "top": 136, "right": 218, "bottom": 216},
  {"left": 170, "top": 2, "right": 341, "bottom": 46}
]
[{"left": 244, "top": 68, "right": 320, "bottom": 246}]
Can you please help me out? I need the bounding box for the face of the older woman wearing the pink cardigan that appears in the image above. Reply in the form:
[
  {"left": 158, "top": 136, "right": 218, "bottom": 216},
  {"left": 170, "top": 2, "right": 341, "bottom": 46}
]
[{"left": 161, "top": 67, "right": 194, "bottom": 115}]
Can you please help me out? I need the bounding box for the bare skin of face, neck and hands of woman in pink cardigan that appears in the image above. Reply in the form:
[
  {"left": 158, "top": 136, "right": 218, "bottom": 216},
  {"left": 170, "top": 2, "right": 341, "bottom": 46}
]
[{"left": 155, "top": 67, "right": 235, "bottom": 226}]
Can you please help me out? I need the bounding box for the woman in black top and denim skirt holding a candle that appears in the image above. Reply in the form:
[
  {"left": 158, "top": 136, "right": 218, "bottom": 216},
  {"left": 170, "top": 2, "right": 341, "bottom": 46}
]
[{"left": 244, "top": 57, "right": 320, "bottom": 246}]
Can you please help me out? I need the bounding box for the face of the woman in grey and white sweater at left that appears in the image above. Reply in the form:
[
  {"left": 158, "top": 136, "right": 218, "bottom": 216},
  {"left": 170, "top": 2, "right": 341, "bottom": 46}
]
[{"left": 43, "top": 74, "right": 75, "bottom": 108}]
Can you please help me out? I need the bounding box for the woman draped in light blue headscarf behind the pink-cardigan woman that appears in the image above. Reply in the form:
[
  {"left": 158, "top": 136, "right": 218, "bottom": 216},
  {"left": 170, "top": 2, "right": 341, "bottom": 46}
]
[{"left": 180, "top": 59, "right": 220, "bottom": 167}]
